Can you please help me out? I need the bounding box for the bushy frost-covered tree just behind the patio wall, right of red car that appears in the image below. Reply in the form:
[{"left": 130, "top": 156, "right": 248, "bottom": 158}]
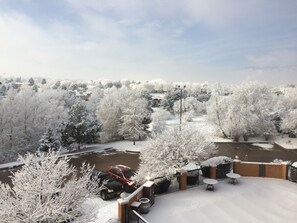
[{"left": 135, "top": 126, "right": 216, "bottom": 182}]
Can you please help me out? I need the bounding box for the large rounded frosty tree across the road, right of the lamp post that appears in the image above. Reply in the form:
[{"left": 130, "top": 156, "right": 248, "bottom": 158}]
[{"left": 208, "top": 83, "right": 275, "bottom": 140}]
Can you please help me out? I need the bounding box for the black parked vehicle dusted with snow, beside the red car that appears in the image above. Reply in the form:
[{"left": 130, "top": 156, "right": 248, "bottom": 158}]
[{"left": 91, "top": 170, "right": 124, "bottom": 200}]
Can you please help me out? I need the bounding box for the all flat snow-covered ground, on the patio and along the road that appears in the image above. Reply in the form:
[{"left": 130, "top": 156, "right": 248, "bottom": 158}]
[{"left": 0, "top": 116, "right": 297, "bottom": 223}]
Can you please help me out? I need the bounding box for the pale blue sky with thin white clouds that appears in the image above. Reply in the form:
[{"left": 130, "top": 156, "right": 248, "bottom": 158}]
[{"left": 0, "top": 0, "right": 297, "bottom": 84}]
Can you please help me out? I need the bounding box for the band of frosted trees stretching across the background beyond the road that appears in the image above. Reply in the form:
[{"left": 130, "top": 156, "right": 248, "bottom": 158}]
[{"left": 0, "top": 78, "right": 297, "bottom": 162}]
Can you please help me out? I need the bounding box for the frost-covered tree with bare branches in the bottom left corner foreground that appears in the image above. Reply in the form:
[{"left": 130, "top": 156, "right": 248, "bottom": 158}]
[{"left": 0, "top": 152, "right": 95, "bottom": 223}]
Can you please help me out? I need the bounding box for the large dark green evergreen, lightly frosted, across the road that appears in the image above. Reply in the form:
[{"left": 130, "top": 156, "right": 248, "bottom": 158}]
[{"left": 61, "top": 101, "right": 100, "bottom": 150}]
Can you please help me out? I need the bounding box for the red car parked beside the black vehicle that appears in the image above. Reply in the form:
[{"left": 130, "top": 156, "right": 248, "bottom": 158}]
[{"left": 107, "top": 165, "right": 137, "bottom": 192}]
